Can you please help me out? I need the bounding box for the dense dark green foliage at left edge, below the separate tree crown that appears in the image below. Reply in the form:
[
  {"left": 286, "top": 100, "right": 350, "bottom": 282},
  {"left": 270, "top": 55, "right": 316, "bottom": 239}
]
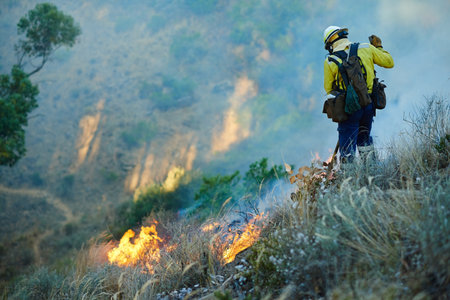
[{"left": 0, "top": 66, "right": 39, "bottom": 166}]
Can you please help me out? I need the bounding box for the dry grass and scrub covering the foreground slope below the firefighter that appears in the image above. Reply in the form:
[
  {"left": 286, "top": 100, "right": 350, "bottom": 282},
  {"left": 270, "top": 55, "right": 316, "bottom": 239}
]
[{"left": 5, "top": 98, "right": 450, "bottom": 299}]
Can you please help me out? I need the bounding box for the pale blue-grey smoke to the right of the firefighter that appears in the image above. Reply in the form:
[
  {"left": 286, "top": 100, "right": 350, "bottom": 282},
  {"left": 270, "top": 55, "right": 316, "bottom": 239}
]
[{"left": 326, "top": 0, "right": 450, "bottom": 148}]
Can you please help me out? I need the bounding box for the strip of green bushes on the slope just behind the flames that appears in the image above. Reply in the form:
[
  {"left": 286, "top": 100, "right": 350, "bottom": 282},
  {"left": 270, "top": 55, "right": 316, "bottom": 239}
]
[{"left": 111, "top": 158, "right": 282, "bottom": 236}]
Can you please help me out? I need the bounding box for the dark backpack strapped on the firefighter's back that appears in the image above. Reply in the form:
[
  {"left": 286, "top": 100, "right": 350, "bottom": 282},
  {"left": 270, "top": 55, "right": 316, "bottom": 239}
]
[{"left": 328, "top": 43, "right": 372, "bottom": 115}]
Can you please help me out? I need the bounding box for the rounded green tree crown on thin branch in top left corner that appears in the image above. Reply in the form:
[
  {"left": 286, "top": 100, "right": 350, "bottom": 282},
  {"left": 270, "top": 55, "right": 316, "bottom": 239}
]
[{"left": 15, "top": 3, "right": 81, "bottom": 75}]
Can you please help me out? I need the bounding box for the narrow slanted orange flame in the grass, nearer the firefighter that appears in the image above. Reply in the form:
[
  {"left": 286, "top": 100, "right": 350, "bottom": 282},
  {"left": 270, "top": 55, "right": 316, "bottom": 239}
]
[{"left": 222, "top": 213, "right": 264, "bottom": 264}]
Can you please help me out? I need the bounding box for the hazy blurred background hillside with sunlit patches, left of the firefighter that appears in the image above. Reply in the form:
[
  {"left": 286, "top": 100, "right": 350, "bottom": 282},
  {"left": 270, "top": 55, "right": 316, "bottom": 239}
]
[{"left": 0, "top": 1, "right": 334, "bottom": 286}]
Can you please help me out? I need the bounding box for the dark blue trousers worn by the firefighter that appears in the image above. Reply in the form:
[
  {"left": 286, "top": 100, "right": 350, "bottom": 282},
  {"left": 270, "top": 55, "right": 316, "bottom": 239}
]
[{"left": 338, "top": 103, "right": 374, "bottom": 162}]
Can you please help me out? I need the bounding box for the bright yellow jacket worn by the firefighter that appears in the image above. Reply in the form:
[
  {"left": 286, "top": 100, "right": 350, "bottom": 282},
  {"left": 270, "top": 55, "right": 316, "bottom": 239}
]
[{"left": 323, "top": 40, "right": 394, "bottom": 94}]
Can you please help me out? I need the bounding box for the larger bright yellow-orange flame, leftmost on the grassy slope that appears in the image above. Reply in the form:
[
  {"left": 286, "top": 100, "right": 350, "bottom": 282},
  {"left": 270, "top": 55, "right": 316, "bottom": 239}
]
[{"left": 108, "top": 221, "right": 163, "bottom": 273}]
